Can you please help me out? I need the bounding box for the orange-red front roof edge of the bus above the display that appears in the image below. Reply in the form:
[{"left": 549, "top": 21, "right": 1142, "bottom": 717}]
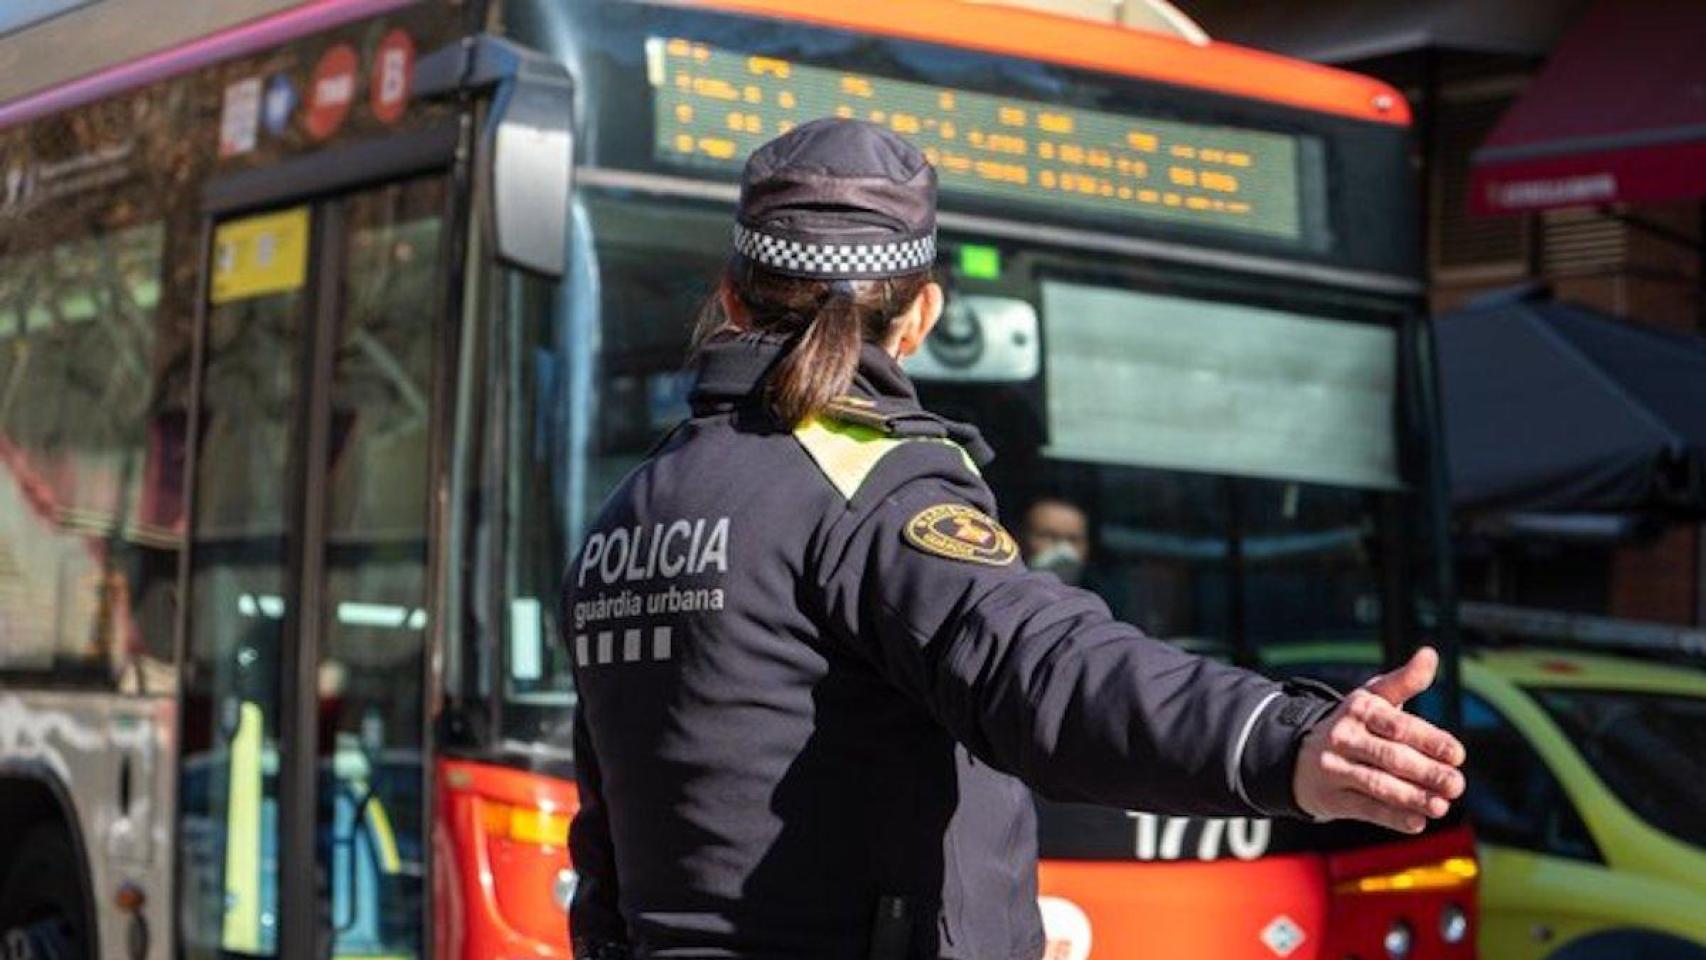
[{"left": 662, "top": 0, "right": 1411, "bottom": 126}]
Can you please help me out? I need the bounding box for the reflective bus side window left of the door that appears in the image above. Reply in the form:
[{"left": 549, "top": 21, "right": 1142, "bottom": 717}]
[{"left": 0, "top": 219, "right": 179, "bottom": 691}]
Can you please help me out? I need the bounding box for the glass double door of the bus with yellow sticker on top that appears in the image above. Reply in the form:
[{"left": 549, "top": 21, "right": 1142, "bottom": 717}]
[{"left": 179, "top": 176, "right": 449, "bottom": 958}]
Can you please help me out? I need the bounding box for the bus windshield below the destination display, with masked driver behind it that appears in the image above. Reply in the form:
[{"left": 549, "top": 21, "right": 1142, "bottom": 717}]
[{"left": 507, "top": 191, "right": 1409, "bottom": 737}]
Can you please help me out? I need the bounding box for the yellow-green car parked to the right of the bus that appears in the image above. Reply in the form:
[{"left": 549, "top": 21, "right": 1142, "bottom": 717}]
[{"left": 1274, "top": 645, "right": 1706, "bottom": 960}]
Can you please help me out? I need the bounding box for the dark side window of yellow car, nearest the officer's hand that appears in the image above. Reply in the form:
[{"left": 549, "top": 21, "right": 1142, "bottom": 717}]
[{"left": 1460, "top": 692, "right": 1602, "bottom": 861}]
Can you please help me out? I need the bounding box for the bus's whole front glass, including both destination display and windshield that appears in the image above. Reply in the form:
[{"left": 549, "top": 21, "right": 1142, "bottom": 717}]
[{"left": 494, "top": 0, "right": 1436, "bottom": 774}]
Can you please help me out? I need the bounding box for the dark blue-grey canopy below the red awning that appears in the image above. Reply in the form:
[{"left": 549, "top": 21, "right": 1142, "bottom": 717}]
[{"left": 1435, "top": 288, "right": 1706, "bottom": 517}]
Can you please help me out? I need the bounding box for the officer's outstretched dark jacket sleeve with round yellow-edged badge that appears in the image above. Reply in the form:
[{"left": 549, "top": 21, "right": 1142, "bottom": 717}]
[{"left": 815, "top": 450, "right": 1332, "bottom": 817}]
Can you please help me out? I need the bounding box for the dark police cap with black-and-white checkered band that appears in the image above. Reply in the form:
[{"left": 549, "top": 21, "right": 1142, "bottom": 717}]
[{"left": 735, "top": 119, "right": 937, "bottom": 280}]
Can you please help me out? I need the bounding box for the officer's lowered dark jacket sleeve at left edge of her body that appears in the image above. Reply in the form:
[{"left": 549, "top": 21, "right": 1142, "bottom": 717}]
[{"left": 568, "top": 704, "right": 628, "bottom": 960}]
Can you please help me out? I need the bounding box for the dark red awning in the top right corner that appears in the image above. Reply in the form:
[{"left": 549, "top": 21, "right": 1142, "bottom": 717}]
[{"left": 1469, "top": 0, "right": 1706, "bottom": 213}]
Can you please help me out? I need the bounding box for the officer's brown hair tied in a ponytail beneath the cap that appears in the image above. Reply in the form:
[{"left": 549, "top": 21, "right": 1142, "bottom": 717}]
[{"left": 693, "top": 261, "right": 931, "bottom": 426}]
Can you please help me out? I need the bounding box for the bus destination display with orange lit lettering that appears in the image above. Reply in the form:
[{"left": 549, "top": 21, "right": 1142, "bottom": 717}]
[{"left": 647, "top": 38, "right": 1303, "bottom": 240}]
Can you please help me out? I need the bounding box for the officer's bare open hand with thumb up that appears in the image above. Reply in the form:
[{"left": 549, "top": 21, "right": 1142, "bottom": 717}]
[{"left": 1291, "top": 646, "right": 1464, "bottom": 834}]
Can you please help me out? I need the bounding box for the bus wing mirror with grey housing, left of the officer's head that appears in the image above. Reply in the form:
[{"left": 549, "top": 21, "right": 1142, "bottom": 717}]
[{"left": 415, "top": 34, "right": 575, "bottom": 280}]
